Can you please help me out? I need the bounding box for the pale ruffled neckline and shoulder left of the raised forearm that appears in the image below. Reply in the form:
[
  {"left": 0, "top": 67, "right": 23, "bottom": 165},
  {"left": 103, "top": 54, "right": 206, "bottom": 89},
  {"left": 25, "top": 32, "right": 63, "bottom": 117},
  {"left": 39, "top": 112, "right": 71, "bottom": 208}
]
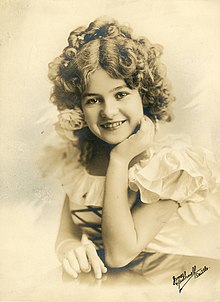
[{"left": 38, "top": 136, "right": 105, "bottom": 206}]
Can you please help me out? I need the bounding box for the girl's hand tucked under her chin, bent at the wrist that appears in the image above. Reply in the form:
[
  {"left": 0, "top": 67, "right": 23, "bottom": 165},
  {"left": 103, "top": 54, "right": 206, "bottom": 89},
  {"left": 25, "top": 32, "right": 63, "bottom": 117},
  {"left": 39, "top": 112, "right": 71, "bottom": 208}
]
[{"left": 111, "top": 116, "right": 155, "bottom": 164}]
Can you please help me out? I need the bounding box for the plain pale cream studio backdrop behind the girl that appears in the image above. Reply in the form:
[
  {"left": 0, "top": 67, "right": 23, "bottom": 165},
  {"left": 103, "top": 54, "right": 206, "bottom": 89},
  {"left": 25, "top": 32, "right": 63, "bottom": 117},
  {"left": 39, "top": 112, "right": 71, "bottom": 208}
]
[{"left": 0, "top": 0, "right": 220, "bottom": 301}]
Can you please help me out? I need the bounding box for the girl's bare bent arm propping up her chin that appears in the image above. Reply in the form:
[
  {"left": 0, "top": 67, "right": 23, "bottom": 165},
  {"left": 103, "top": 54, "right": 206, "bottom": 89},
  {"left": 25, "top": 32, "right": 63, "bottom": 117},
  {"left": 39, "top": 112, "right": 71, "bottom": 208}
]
[{"left": 102, "top": 120, "right": 177, "bottom": 267}]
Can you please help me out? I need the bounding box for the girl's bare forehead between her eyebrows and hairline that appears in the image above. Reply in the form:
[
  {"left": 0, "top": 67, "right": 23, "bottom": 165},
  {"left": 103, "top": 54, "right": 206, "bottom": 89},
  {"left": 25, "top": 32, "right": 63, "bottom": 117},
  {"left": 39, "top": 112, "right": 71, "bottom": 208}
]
[{"left": 87, "top": 69, "right": 127, "bottom": 93}]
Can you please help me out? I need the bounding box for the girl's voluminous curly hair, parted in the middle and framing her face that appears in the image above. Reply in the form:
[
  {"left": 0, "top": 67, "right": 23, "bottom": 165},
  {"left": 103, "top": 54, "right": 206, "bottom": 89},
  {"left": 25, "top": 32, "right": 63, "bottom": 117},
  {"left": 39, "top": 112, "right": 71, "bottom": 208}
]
[{"left": 48, "top": 18, "right": 175, "bottom": 164}]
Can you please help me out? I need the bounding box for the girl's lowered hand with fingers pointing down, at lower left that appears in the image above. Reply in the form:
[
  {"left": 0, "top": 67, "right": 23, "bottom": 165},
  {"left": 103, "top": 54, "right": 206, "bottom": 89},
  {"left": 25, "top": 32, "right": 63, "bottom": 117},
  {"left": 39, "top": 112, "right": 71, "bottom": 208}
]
[{"left": 62, "top": 234, "right": 107, "bottom": 279}]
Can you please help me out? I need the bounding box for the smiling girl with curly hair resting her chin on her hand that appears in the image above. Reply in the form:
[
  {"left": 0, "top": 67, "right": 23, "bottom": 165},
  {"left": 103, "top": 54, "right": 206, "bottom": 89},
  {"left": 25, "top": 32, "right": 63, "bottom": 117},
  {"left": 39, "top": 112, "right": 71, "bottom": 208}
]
[{"left": 42, "top": 18, "right": 217, "bottom": 279}]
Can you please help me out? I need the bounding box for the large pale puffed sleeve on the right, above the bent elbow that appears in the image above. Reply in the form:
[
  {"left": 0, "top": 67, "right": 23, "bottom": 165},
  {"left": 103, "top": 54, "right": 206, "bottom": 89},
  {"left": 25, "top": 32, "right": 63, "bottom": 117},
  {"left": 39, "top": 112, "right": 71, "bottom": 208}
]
[{"left": 129, "top": 139, "right": 220, "bottom": 206}]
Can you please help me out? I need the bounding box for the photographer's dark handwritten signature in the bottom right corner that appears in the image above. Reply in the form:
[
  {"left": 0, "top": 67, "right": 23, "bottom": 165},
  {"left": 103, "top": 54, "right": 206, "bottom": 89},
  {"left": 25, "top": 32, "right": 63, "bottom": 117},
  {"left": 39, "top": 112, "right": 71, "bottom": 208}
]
[{"left": 173, "top": 265, "right": 209, "bottom": 293}]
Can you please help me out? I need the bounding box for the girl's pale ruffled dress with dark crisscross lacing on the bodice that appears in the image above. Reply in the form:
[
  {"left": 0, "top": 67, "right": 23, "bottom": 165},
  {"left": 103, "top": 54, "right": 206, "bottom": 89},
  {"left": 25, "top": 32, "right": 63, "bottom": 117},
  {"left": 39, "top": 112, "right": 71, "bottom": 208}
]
[{"left": 40, "top": 136, "right": 220, "bottom": 256}]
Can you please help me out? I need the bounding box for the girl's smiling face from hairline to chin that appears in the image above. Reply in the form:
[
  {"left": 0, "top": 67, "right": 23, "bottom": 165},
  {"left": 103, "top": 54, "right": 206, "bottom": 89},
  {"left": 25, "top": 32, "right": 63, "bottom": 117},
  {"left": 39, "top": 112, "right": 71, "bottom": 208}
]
[{"left": 82, "top": 69, "right": 143, "bottom": 144}]
